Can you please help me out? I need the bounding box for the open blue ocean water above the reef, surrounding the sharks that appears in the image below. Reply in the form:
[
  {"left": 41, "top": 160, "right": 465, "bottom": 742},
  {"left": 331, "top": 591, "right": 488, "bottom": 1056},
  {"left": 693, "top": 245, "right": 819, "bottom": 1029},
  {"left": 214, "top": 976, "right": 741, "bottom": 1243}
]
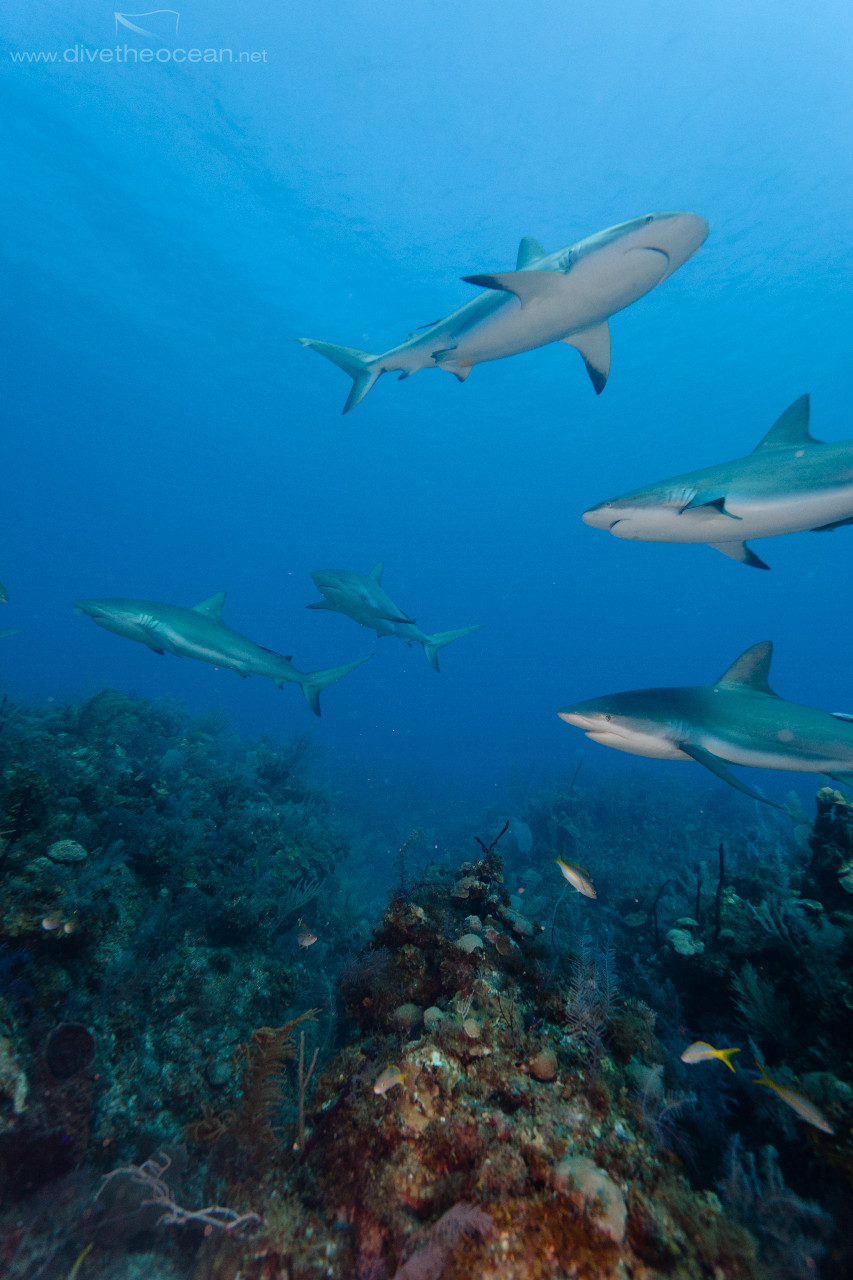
[{"left": 0, "top": 0, "right": 853, "bottom": 797}]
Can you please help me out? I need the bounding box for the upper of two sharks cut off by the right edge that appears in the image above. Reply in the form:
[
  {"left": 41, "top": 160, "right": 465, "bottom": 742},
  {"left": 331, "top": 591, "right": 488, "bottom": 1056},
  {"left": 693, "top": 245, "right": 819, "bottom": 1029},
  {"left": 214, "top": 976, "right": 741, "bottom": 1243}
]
[{"left": 581, "top": 396, "right": 853, "bottom": 568}]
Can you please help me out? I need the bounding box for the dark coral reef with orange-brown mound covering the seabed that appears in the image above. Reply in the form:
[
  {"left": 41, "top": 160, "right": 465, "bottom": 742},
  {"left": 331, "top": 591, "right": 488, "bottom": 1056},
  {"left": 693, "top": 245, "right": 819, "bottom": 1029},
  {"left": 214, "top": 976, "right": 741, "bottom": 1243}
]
[{"left": 0, "top": 690, "right": 853, "bottom": 1280}]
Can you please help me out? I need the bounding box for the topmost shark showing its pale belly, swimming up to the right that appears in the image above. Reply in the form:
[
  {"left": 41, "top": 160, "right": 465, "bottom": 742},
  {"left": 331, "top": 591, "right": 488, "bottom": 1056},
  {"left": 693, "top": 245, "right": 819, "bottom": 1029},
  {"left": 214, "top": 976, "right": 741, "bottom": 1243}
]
[{"left": 296, "top": 212, "right": 708, "bottom": 413}]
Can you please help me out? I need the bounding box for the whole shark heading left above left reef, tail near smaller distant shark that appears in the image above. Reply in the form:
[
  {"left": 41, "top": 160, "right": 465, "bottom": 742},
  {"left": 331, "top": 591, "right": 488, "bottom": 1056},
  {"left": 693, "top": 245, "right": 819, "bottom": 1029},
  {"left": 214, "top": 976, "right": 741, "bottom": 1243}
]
[{"left": 74, "top": 591, "right": 373, "bottom": 716}]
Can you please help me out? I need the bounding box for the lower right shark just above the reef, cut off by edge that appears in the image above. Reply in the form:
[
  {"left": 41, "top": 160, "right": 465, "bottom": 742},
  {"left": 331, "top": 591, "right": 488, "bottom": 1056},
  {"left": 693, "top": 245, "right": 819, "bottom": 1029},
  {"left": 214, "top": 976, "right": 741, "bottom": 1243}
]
[{"left": 558, "top": 640, "right": 853, "bottom": 809}]
